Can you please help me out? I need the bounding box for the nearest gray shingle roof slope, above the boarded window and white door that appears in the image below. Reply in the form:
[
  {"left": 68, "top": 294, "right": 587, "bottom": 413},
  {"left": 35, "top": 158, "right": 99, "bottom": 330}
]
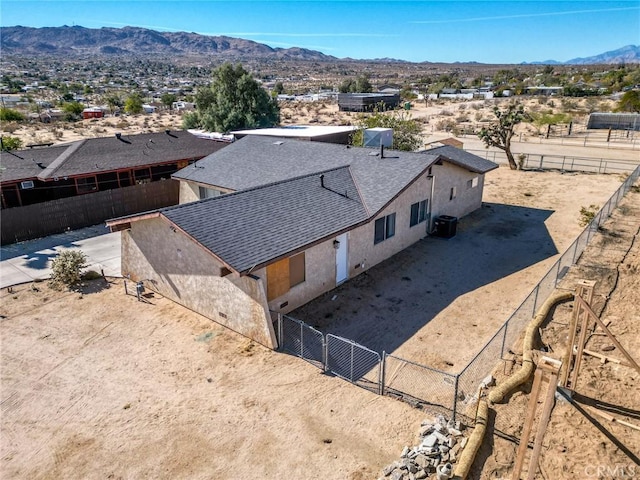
[{"left": 160, "top": 166, "right": 368, "bottom": 272}]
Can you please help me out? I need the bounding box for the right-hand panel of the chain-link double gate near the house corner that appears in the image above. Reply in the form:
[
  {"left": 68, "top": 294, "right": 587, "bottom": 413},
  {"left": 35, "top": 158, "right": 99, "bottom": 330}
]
[{"left": 325, "top": 334, "right": 382, "bottom": 393}]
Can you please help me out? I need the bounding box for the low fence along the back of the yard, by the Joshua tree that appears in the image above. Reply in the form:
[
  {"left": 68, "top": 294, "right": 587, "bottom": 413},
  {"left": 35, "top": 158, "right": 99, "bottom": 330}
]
[{"left": 467, "top": 150, "right": 637, "bottom": 173}]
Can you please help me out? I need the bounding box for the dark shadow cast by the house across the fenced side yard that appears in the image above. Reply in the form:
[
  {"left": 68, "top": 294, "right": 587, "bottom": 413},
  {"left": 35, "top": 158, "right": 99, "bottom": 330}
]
[{"left": 291, "top": 203, "right": 558, "bottom": 352}]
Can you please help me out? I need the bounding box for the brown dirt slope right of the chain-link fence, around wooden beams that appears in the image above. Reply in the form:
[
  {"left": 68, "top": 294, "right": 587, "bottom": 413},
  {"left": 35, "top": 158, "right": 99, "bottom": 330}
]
[{"left": 480, "top": 187, "right": 640, "bottom": 480}]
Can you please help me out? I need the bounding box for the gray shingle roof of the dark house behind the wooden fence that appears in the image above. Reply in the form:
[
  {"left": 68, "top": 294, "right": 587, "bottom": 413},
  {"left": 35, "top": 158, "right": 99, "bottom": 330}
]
[{"left": 0, "top": 130, "right": 228, "bottom": 182}]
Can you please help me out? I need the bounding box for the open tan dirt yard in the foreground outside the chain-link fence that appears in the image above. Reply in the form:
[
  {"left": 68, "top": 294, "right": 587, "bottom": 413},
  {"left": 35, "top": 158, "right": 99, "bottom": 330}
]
[{"left": 0, "top": 280, "right": 424, "bottom": 480}]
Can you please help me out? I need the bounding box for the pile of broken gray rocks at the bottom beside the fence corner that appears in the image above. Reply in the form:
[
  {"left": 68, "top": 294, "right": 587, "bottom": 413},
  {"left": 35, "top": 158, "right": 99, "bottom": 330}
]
[{"left": 381, "top": 415, "right": 467, "bottom": 480}]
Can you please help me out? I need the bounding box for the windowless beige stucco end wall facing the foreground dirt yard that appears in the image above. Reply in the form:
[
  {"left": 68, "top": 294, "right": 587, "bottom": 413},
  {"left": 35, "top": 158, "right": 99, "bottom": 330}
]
[{"left": 122, "top": 218, "right": 276, "bottom": 348}]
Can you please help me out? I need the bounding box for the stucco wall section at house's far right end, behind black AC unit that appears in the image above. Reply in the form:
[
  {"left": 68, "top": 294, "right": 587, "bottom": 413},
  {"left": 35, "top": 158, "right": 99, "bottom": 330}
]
[{"left": 431, "top": 163, "right": 484, "bottom": 218}]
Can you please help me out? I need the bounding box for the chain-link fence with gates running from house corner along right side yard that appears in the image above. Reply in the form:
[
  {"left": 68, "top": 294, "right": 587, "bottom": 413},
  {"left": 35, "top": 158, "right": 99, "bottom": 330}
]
[{"left": 272, "top": 166, "right": 640, "bottom": 429}]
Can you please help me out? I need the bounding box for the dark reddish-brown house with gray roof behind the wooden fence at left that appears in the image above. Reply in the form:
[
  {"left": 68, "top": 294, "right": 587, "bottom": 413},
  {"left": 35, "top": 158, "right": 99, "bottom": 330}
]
[{"left": 0, "top": 130, "right": 227, "bottom": 209}]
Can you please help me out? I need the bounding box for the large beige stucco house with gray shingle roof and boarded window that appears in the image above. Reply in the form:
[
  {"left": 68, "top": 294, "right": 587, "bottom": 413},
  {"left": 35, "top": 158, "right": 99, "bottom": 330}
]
[{"left": 107, "top": 136, "right": 497, "bottom": 347}]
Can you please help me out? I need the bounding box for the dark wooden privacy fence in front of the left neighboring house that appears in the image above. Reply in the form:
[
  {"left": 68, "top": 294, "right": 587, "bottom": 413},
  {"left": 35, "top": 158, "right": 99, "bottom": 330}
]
[{"left": 2, "top": 180, "right": 179, "bottom": 245}]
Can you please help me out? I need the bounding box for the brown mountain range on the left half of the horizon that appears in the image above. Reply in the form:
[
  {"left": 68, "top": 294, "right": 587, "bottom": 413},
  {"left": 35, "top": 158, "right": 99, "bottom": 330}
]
[{"left": 0, "top": 25, "right": 336, "bottom": 61}]
